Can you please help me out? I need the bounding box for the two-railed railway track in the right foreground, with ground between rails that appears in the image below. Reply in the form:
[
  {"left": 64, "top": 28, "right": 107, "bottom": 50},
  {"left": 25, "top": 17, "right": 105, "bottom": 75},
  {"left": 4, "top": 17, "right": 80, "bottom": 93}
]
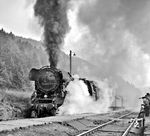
[{"left": 76, "top": 112, "right": 142, "bottom": 136}]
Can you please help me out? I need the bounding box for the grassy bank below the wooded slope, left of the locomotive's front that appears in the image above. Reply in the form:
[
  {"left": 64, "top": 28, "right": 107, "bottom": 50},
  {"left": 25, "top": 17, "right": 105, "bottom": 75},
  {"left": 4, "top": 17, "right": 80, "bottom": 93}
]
[{"left": 0, "top": 90, "right": 32, "bottom": 120}]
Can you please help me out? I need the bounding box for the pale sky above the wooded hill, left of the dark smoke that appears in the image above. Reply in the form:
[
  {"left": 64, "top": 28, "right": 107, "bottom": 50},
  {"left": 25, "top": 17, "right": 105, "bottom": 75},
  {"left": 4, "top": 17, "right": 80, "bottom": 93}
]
[{"left": 0, "top": 0, "right": 41, "bottom": 40}]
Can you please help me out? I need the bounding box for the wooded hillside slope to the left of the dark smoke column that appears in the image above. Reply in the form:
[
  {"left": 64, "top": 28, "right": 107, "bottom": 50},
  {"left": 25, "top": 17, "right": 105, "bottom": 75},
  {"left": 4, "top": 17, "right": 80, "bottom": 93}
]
[{"left": 0, "top": 29, "right": 47, "bottom": 90}]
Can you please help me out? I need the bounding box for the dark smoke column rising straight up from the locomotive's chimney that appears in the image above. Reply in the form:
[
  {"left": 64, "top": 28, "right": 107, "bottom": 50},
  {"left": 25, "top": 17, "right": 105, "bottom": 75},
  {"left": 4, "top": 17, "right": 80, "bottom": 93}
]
[{"left": 34, "top": 0, "right": 69, "bottom": 67}]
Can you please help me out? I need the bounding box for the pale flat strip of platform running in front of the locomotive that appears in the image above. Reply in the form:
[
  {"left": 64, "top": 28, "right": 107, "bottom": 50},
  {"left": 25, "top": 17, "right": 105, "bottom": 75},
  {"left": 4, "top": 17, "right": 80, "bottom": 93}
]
[{"left": 0, "top": 114, "right": 93, "bottom": 133}]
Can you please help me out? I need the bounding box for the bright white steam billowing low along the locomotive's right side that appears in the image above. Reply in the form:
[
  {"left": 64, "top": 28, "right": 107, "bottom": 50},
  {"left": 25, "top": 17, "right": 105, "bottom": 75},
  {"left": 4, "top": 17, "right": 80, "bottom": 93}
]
[{"left": 59, "top": 77, "right": 113, "bottom": 114}]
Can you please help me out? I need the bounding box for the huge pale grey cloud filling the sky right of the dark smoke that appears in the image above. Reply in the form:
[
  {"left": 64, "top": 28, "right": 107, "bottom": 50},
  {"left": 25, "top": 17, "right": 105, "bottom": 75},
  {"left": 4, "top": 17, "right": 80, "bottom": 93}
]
[{"left": 61, "top": 0, "right": 150, "bottom": 107}]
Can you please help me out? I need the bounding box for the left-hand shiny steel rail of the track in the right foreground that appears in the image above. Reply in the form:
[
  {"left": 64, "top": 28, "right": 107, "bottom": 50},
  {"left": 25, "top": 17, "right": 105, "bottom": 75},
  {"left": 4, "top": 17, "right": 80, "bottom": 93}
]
[{"left": 76, "top": 112, "right": 133, "bottom": 136}]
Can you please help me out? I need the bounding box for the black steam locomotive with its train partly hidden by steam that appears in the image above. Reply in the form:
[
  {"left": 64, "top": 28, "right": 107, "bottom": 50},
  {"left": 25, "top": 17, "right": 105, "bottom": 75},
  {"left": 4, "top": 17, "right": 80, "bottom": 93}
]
[{"left": 29, "top": 66, "right": 99, "bottom": 117}]
